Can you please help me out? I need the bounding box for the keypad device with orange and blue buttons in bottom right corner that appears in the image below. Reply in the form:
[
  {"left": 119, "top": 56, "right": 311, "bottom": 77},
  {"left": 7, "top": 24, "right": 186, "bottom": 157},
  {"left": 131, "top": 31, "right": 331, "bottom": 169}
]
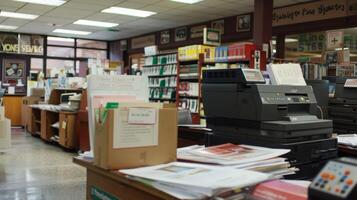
[{"left": 309, "top": 158, "right": 357, "bottom": 200}]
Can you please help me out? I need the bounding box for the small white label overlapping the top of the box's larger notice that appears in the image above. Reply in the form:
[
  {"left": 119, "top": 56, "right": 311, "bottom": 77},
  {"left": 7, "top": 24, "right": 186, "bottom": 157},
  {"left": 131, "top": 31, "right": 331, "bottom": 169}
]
[{"left": 128, "top": 108, "right": 156, "bottom": 124}]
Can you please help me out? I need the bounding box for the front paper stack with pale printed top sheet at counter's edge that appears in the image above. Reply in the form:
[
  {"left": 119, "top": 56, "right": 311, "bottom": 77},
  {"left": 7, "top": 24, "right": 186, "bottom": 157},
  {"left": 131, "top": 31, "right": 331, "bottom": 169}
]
[{"left": 120, "top": 162, "right": 272, "bottom": 199}]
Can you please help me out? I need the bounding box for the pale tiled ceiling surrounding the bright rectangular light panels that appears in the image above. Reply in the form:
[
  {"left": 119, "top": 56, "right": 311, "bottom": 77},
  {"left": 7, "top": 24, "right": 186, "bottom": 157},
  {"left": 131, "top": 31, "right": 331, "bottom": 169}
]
[{"left": 0, "top": 0, "right": 310, "bottom": 40}]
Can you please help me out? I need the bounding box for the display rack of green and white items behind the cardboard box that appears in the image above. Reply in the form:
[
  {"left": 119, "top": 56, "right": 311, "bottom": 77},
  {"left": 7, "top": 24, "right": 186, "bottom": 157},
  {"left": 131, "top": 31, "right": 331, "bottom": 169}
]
[{"left": 143, "top": 52, "right": 178, "bottom": 103}]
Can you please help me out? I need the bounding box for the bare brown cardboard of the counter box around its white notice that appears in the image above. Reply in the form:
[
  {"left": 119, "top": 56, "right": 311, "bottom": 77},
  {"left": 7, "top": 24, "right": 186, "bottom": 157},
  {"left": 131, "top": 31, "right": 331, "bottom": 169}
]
[{"left": 94, "top": 107, "right": 177, "bottom": 170}]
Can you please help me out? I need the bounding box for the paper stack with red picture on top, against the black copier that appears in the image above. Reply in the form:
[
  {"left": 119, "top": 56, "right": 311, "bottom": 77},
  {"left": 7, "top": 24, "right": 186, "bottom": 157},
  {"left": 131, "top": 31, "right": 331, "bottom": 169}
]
[{"left": 177, "top": 144, "right": 298, "bottom": 178}]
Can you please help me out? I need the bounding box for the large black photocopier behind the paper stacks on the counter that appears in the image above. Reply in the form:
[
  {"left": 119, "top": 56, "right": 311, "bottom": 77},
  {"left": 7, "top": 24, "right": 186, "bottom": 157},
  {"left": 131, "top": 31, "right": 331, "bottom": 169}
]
[{"left": 202, "top": 69, "right": 337, "bottom": 179}]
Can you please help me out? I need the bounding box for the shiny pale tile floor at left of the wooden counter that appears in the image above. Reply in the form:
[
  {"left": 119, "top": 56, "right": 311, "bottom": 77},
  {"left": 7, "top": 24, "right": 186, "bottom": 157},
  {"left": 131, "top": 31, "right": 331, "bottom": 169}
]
[{"left": 0, "top": 129, "right": 86, "bottom": 200}]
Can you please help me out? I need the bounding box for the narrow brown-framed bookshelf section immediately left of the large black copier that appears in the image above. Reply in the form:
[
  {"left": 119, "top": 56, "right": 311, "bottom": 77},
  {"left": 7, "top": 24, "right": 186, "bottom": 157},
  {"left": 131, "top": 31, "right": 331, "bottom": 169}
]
[{"left": 176, "top": 54, "right": 204, "bottom": 124}]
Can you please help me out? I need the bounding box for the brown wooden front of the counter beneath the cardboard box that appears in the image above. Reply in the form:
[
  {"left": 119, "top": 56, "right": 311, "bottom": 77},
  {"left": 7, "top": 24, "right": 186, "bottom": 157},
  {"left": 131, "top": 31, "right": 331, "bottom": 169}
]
[{"left": 73, "top": 158, "right": 176, "bottom": 200}]
